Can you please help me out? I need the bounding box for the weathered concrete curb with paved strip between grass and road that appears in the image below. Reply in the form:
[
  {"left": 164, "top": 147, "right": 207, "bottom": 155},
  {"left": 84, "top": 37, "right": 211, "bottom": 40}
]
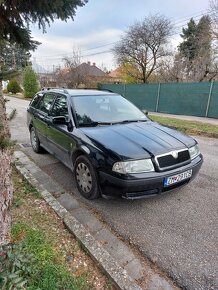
[{"left": 14, "top": 151, "right": 178, "bottom": 290}]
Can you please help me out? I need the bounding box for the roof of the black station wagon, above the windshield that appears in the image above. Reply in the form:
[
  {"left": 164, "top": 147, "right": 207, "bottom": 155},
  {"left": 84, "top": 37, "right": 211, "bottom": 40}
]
[{"left": 42, "top": 88, "right": 116, "bottom": 96}]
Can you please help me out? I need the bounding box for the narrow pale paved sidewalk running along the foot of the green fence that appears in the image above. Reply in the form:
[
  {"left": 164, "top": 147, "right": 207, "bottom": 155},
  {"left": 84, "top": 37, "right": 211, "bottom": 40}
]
[{"left": 148, "top": 112, "right": 218, "bottom": 126}]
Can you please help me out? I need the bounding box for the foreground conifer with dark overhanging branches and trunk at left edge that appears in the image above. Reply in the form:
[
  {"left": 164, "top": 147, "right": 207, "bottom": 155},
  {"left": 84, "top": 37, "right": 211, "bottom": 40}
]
[{"left": 0, "top": 0, "right": 87, "bottom": 246}]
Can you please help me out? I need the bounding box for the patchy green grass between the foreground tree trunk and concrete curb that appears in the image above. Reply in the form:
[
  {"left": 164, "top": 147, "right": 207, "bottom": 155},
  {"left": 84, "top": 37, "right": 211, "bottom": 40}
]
[{"left": 11, "top": 170, "right": 92, "bottom": 290}]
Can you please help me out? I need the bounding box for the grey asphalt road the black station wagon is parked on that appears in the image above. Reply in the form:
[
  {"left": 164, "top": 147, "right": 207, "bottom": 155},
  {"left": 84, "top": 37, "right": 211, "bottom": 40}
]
[{"left": 7, "top": 98, "right": 218, "bottom": 290}]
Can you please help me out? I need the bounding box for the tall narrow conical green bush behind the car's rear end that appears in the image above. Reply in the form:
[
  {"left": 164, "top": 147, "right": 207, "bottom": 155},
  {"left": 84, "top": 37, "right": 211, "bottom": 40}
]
[{"left": 23, "top": 66, "right": 39, "bottom": 98}]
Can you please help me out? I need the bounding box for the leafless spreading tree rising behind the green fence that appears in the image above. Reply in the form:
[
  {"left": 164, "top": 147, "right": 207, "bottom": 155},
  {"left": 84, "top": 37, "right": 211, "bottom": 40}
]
[{"left": 113, "top": 15, "right": 172, "bottom": 83}]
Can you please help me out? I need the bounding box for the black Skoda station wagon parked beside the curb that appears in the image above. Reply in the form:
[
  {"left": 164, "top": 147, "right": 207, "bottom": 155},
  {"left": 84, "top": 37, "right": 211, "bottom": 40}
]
[{"left": 27, "top": 89, "right": 203, "bottom": 199}]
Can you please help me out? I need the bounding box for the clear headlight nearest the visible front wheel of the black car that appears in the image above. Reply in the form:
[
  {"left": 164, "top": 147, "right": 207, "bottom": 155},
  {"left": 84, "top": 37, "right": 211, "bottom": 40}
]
[{"left": 112, "top": 159, "right": 154, "bottom": 174}]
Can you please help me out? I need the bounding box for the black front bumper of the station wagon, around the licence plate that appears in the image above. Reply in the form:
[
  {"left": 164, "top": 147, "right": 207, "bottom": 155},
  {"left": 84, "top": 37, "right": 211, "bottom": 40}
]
[{"left": 99, "top": 155, "right": 203, "bottom": 199}]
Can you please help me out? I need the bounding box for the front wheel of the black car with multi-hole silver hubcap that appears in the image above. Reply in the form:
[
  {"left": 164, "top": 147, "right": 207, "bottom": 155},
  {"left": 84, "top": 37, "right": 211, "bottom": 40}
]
[{"left": 74, "top": 155, "right": 100, "bottom": 199}]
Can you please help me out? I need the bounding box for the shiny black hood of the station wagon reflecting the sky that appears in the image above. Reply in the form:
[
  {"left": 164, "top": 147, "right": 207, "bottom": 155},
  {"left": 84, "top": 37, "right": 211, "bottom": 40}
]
[{"left": 80, "top": 121, "right": 196, "bottom": 160}]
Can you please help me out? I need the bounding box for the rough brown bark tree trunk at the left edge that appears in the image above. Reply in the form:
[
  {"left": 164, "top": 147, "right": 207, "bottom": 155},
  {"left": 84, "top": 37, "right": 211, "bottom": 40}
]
[{"left": 0, "top": 80, "right": 13, "bottom": 246}]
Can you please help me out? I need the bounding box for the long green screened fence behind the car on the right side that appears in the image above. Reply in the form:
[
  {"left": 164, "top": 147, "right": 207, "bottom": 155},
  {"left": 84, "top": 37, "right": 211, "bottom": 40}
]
[{"left": 100, "top": 82, "right": 218, "bottom": 118}]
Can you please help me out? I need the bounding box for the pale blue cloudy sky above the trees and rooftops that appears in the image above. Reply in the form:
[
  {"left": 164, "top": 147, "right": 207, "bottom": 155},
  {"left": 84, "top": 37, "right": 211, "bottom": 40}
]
[{"left": 32, "top": 0, "right": 209, "bottom": 70}]
